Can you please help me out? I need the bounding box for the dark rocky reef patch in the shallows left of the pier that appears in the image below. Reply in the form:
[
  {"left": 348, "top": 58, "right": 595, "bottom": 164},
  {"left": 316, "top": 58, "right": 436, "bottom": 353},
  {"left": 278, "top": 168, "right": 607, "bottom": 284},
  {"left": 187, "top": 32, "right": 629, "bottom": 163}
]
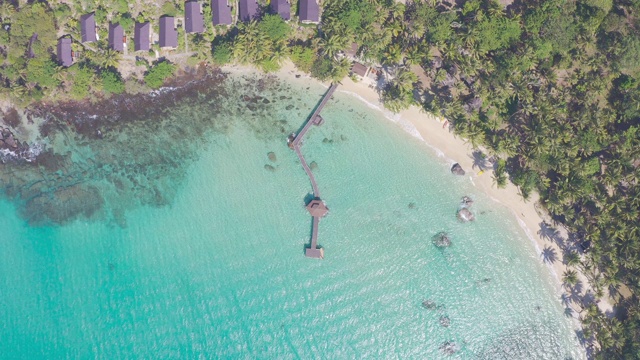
[{"left": 0, "top": 67, "right": 312, "bottom": 226}]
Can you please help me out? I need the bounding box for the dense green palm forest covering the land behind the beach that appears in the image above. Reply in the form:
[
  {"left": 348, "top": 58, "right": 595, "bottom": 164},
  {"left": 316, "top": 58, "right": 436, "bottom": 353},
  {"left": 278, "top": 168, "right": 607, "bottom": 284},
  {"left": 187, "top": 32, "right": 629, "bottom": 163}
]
[{"left": 0, "top": 0, "right": 640, "bottom": 359}]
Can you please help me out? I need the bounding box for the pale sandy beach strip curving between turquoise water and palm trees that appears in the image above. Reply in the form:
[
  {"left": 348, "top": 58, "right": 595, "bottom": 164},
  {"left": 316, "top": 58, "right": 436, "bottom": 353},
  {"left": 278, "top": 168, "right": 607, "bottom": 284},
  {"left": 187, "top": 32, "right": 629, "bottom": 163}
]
[{"left": 241, "top": 61, "right": 613, "bottom": 328}]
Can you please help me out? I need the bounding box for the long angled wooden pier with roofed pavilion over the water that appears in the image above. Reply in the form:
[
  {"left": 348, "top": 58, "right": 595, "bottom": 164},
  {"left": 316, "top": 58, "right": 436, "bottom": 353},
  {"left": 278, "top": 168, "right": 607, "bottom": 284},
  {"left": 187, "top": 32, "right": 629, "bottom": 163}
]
[{"left": 289, "top": 84, "right": 338, "bottom": 259}]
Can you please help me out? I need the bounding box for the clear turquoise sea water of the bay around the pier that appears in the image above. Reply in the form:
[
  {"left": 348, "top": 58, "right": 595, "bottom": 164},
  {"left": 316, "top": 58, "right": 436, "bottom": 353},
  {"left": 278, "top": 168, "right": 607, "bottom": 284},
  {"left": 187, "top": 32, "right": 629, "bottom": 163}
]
[{"left": 0, "top": 73, "right": 584, "bottom": 359}]
